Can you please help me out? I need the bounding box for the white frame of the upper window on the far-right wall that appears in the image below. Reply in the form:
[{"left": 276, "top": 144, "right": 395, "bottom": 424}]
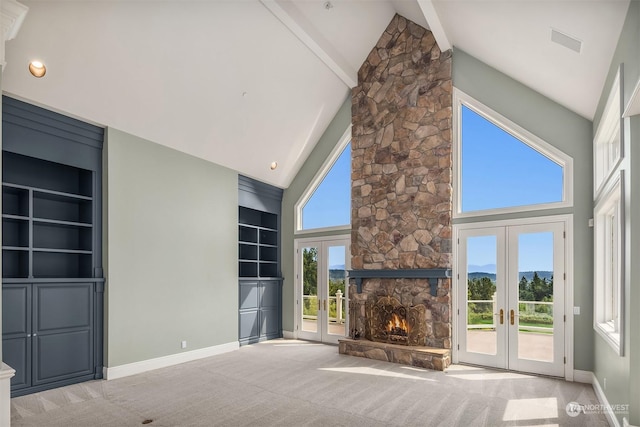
[{"left": 593, "top": 64, "right": 624, "bottom": 200}]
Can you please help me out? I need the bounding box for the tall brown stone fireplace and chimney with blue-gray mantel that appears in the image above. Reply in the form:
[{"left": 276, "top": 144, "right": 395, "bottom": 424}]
[{"left": 340, "top": 15, "right": 452, "bottom": 369}]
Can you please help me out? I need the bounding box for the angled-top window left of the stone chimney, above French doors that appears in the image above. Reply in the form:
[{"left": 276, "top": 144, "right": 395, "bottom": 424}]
[{"left": 298, "top": 137, "right": 351, "bottom": 230}]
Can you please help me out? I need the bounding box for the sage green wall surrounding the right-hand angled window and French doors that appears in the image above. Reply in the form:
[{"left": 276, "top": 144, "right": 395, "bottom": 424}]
[{"left": 452, "top": 49, "right": 594, "bottom": 371}]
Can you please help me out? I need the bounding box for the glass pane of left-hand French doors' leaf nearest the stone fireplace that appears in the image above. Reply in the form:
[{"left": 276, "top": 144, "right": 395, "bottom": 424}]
[{"left": 327, "top": 246, "right": 347, "bottom": 336}]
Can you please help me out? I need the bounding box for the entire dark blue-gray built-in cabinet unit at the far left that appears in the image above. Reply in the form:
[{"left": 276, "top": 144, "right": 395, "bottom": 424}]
[{"left": 2, "top": 97, "right": 104, "bottom": 396}]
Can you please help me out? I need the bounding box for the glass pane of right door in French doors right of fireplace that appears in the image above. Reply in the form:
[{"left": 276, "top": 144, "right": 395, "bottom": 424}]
[{"left": 518, "top": 232, "right": 553, "bottom": 362}]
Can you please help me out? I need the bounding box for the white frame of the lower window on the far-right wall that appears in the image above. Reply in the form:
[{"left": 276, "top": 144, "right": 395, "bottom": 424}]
[{"left": 593, "top": 170, "right": 625, "bottom": 356}]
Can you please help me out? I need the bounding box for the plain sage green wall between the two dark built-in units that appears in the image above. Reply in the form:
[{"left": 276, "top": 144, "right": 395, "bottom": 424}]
[{"left": 104, "top": 128, "right": 238, "bottom": 367}]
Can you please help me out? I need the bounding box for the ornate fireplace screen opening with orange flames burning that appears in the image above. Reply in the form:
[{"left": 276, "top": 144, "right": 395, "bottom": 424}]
[{"left": 365, "top": 296, "right": 427, "bottom": 346}]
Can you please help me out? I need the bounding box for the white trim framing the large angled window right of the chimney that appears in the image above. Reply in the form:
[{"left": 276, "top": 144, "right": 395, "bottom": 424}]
[{"left": 453, "top": 88, "right": 573, "bottom": 218}]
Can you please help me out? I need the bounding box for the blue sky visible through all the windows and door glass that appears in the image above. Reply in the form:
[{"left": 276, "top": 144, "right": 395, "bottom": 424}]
[{"left": 302, "top": 106, "right": 563, "bottom": 271}]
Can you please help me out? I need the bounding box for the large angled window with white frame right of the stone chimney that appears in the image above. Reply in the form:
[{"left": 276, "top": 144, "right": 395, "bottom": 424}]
[{"left": 456, "top": 91, "right": 572, "bottom": 216}]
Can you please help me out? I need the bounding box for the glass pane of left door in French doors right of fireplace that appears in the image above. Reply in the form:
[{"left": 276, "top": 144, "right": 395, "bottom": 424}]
[{"left": 467, "top": 236, "right": 499, "bottom": 354}]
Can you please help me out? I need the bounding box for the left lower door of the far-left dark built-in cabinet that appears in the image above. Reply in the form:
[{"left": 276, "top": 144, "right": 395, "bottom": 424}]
[{"left": 2, "top": 284, "right": 31, "bottom": 390}]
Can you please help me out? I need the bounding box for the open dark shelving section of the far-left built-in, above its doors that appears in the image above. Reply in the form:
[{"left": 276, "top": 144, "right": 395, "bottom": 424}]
[{"left": 2, "top": 152, "right": 94, "bottom": 279}]
